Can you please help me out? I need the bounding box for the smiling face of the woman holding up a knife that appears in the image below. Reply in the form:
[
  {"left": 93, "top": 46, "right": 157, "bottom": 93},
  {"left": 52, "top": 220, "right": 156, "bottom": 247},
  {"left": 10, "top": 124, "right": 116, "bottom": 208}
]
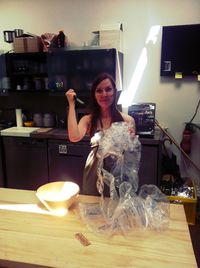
[{"left": 95, "top": 78, "right": 115, "bottom": 108}]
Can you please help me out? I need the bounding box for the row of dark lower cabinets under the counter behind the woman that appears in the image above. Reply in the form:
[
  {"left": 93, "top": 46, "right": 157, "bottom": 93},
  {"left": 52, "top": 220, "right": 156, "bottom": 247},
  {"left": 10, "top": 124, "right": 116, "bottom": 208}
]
[{"left": 0, "top": 131, "right": 162, "bottom": 191}]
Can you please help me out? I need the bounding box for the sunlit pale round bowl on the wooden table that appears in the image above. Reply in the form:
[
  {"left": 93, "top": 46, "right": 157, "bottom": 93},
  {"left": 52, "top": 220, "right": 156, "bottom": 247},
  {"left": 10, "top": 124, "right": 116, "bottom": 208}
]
[{"left": 36, "top": 181, "right": 80, "bottom": 215}]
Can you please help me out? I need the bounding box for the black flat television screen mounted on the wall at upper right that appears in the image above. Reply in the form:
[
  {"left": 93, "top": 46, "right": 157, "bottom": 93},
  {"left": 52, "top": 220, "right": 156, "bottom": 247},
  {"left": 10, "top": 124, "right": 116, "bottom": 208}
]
[{"left": 160, "top": 24, "right": 200, "bottom": 76}]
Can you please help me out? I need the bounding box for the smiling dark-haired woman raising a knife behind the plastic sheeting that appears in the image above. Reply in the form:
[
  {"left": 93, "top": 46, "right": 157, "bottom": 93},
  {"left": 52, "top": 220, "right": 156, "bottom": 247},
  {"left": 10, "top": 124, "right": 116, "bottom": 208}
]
[{"left": 66, "top": 73, "right": 135, "bottom": 195}]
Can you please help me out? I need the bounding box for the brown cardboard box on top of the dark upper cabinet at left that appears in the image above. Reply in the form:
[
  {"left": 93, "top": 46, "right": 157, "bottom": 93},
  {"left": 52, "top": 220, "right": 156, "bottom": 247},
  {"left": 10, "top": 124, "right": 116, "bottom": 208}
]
[{"left": 13, "top": 36, "right": 42, "bottom": 53}]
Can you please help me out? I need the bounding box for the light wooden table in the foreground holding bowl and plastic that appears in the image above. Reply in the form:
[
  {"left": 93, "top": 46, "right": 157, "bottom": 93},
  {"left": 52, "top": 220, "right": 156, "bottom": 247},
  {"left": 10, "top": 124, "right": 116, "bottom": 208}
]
[{"left": 0, "top": 188, "right": 197, "bottom": 268}]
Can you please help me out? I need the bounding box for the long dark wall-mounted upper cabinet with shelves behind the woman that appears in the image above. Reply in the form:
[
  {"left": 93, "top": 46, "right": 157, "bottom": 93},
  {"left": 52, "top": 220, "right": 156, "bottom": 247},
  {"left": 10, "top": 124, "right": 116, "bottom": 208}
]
[{"left": 0, "top": 48, "right": 123, "bottom": 115}]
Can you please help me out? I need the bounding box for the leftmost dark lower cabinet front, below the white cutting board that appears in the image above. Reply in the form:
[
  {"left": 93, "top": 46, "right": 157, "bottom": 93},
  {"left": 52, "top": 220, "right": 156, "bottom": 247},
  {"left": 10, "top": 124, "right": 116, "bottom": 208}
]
[{"left": 3, "top": 137, "right": 48, "bottom": 190}]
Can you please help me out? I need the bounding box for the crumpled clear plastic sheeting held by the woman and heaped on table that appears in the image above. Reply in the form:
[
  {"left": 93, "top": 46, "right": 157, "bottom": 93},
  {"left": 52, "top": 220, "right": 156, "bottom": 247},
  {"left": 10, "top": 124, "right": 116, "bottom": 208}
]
[{"left": 79, "top": 122, "right": 169, "bottom": 236}]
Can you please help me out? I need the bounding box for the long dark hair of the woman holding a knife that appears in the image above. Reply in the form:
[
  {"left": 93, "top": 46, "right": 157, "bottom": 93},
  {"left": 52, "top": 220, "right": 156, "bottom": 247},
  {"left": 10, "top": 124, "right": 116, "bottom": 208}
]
[{"left": 89, "top": 73, "right": 124, "bottom": 136}]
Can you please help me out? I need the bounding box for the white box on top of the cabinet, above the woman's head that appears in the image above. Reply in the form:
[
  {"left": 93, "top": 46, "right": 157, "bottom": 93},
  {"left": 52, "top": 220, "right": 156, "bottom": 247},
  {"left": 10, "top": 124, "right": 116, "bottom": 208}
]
[{"left": 99, "top": 23, "right": 123, "bottom": 52}]
